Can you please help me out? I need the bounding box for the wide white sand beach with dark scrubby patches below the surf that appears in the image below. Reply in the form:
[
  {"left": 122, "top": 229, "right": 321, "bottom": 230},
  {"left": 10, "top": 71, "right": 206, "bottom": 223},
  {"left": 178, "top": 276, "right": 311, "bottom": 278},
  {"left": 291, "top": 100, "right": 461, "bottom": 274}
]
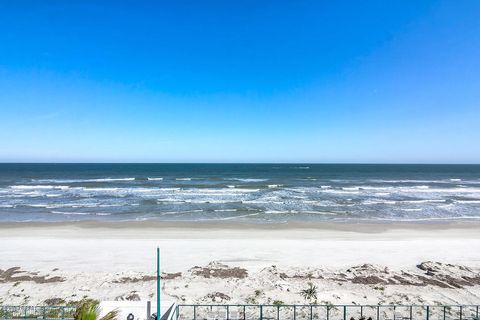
[{"left": 0, "top": 221, "right": 480, "bottom": 305}]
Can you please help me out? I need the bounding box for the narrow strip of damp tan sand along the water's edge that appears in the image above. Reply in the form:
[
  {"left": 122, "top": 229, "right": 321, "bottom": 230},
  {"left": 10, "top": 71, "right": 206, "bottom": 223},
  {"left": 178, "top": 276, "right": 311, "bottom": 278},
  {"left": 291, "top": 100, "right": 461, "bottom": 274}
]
[{"left": 0, "top": 221, "right": 480, "bottom": 240}]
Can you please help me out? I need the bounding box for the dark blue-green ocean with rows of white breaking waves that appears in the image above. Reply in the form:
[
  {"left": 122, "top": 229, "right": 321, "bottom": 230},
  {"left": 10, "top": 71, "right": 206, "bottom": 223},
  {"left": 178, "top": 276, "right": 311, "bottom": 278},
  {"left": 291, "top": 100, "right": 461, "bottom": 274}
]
[{"left": 0, "top": 164, "right": 480, "bottom": 223}]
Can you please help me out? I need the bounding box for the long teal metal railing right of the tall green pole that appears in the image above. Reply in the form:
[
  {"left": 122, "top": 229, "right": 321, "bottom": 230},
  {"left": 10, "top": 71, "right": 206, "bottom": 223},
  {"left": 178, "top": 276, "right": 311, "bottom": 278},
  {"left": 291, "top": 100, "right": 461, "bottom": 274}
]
[{"left": 175, "top": 305, "right": 480, "bottom": 320}]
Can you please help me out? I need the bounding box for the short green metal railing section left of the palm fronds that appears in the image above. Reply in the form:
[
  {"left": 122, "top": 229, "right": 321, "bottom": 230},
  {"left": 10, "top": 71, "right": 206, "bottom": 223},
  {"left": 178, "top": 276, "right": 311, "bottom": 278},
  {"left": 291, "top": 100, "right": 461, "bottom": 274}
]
[{"left": 0, "top": 305, "right": 76, "bottom": 320}]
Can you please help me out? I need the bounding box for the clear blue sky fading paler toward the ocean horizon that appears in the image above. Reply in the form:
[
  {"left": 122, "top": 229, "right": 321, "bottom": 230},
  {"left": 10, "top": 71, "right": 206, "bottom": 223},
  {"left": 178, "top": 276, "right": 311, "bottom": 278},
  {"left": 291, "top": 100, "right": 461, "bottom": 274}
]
[{"left": 0, "top": 0, "right": 480, "bottom": 163}]
